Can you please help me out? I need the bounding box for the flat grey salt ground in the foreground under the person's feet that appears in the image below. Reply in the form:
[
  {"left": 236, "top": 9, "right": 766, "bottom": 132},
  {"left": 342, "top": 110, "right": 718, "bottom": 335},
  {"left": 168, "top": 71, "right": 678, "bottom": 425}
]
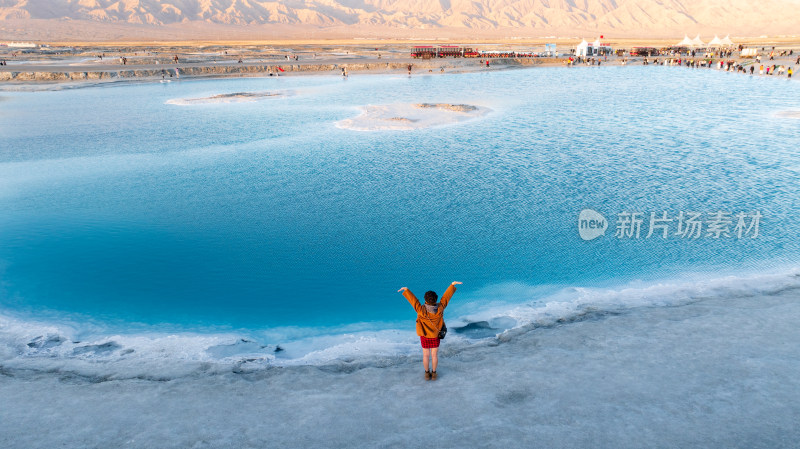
[{"left": 0, "top": 284, "right": 800, "bottom": 449}]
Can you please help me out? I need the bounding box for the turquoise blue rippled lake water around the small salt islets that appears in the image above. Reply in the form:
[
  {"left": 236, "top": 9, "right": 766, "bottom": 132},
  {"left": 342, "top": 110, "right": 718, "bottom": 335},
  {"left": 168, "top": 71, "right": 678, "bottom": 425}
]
[{"left": 0, "top": 66, "right": 800, "bottom": 329}]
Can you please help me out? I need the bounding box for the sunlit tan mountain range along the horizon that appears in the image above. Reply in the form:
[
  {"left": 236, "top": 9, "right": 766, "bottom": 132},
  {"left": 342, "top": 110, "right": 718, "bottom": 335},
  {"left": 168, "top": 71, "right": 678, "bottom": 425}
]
[{"left": 0, "top": 0, "right": 800, "bottom": 38}]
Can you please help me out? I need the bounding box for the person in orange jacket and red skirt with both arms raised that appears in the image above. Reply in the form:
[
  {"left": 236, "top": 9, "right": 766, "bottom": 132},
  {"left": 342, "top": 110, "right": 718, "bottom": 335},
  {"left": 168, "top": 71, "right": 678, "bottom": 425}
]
[{"left": 398, "top": 281, "right": 461, "bottom": 380}]
